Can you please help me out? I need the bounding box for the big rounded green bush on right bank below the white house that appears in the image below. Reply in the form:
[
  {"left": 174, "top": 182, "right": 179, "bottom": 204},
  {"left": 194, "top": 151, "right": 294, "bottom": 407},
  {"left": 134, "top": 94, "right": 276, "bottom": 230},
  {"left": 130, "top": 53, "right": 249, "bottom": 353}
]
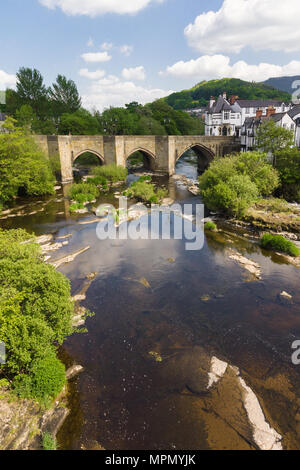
[{"left": 199, "top": 152, "right": 279, "bottom": 217}]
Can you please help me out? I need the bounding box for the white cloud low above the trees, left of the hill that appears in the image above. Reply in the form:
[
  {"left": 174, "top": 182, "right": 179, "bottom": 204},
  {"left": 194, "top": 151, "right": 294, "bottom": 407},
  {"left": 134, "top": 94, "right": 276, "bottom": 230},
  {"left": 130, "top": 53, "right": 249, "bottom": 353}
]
[{"left": 83, "top": 75, "right": 173, "bottom": 111}]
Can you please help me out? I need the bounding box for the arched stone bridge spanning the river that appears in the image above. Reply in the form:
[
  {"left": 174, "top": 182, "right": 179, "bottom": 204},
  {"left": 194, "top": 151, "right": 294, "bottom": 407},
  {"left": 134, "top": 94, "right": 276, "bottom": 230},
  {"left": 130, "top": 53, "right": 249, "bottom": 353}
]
[{"left": 36, "top": 135, "right": 240, "bottom": 183}]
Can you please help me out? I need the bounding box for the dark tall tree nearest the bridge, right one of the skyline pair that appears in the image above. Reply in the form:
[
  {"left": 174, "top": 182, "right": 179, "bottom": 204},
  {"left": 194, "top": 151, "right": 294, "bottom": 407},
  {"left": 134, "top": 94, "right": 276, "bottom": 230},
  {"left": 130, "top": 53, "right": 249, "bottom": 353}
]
[{"left": 49, "top": 75, "right": 81, "bottom": 117}]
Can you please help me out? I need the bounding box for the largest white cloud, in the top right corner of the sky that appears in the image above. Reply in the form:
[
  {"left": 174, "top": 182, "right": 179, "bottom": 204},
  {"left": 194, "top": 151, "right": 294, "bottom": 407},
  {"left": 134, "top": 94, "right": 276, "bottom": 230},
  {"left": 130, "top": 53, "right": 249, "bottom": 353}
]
[{"left": 184, "top": 0, "right": 300, "bottom": 54}]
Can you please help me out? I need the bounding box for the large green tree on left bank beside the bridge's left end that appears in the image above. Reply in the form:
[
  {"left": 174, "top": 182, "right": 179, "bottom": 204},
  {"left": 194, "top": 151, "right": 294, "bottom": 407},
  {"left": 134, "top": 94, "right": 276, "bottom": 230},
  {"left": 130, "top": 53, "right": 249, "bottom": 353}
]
[{"left": 0, "top": 118, "right": 54, "bottom": 203}]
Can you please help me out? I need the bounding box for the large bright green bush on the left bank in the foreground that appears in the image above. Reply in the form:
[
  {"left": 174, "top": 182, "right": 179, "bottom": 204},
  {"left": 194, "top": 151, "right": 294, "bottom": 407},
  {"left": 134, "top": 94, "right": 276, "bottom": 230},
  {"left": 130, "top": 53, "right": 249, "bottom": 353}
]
[{"left": 0, "top": 230, "right": 74, "bottom": 374}]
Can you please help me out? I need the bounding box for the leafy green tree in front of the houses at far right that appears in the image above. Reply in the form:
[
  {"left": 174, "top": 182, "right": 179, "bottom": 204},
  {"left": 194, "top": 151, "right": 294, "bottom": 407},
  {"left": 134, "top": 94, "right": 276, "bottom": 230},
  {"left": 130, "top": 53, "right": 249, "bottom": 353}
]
[{"left": 256, "top": 119, "right": 295, "bottom": 156}]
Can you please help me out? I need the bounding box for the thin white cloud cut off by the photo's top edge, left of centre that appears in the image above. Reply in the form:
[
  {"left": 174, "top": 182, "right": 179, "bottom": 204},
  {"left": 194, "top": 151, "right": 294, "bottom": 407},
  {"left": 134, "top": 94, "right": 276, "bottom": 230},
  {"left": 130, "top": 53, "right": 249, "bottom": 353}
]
[{"left": 39, "top": 0, "right": 164, "bottom": 17}]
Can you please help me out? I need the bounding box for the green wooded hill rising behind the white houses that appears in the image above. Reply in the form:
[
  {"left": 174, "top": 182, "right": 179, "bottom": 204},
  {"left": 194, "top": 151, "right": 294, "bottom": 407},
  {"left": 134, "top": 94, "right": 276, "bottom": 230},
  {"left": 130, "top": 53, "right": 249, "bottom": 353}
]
[{"left": 165, "top": 78, "right": 291, "bottom": 109}]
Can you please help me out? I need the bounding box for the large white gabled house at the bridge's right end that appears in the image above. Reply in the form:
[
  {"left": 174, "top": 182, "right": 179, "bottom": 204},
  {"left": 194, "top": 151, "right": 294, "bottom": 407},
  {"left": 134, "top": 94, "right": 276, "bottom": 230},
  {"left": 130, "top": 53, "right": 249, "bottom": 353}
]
[{"left": 205, "top": 92, "right": 292, "bottom": 137}]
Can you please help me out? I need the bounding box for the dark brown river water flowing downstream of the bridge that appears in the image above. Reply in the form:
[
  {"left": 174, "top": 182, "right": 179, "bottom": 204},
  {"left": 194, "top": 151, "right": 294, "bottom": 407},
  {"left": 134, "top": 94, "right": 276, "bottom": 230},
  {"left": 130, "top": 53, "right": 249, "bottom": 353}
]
[{"left": 0, "top": 154, "right": 300, "bottom": 450}]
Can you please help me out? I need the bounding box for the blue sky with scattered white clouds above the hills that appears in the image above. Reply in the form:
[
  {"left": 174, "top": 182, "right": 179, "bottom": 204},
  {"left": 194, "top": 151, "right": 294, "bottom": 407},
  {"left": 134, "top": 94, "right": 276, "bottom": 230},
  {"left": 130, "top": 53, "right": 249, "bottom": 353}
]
[{"left": 0, "top": 0, "right": 300, "bottom": 109}]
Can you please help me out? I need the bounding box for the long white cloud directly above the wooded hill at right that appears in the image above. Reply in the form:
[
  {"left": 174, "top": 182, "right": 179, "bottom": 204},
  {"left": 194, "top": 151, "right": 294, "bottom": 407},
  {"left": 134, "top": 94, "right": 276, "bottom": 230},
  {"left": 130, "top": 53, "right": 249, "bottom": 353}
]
[{"left": 161, "top": 54, "right": 300, "bottom": 81}]
